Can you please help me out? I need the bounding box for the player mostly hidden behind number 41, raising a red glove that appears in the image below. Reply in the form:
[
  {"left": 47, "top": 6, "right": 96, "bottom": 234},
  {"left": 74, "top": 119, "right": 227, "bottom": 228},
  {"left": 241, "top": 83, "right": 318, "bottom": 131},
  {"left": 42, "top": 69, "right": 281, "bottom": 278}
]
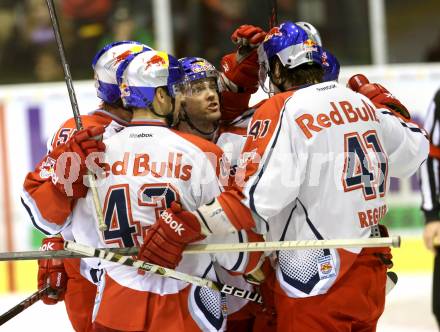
[{"left": 216, "top": 22, "right": 339, "bottom": 331}]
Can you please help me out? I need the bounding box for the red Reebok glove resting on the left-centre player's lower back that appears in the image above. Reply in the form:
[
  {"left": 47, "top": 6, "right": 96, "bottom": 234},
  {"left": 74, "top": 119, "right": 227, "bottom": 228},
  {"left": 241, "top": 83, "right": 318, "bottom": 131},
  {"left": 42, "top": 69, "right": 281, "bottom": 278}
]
[{"left": 138, "top": 202, "right": 205, "bottom": 269}]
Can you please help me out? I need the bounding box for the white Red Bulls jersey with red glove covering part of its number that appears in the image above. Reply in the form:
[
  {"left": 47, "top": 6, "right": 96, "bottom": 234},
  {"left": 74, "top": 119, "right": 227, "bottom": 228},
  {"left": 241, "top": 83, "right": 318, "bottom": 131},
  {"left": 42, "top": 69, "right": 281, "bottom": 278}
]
[{"left": 72, "top": 120, "right": 246, "bottom": 330}]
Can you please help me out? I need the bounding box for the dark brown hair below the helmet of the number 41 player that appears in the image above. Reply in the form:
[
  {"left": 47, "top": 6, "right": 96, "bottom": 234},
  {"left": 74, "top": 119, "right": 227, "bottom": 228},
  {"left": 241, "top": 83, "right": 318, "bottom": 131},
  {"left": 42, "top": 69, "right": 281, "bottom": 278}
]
[{"left": 269, "top": 56, "right": 324, "bottom": 90}]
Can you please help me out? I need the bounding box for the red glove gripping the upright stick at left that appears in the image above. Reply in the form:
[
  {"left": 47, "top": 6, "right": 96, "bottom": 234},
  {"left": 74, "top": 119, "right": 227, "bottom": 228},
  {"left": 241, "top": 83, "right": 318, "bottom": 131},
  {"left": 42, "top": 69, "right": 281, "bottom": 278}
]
[{"left": 45, "top": 126, "right": 105, "bottom": 198}]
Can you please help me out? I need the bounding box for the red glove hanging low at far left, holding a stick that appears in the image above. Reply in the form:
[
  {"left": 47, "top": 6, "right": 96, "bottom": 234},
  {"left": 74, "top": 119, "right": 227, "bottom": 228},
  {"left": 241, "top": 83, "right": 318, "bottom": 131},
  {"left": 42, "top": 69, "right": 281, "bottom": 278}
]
[{"left": 38, "top": 237, "right": 67, "bottom": 304}]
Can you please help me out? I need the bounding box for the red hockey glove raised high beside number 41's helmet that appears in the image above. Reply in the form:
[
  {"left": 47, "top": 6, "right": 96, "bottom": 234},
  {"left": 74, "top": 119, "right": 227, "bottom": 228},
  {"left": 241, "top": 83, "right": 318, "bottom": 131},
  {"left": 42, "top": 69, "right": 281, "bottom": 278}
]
[{"left": 221, "top": 25, "right": 266, "bottom": 94}]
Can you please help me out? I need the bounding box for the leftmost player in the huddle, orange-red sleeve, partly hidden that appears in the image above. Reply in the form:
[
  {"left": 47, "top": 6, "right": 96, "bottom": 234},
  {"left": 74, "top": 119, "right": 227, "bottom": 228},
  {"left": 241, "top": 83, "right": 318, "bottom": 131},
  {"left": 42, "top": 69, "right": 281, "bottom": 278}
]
[{"left": 22, "top": 41, "right": 150, "bottom": 331}]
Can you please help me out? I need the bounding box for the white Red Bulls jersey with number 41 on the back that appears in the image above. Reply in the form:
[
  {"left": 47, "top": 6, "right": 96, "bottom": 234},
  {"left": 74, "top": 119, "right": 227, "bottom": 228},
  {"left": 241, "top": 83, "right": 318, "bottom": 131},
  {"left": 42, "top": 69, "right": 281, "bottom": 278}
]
[{"left": 222, "top": 82, "right": 428, "bottom": 297}]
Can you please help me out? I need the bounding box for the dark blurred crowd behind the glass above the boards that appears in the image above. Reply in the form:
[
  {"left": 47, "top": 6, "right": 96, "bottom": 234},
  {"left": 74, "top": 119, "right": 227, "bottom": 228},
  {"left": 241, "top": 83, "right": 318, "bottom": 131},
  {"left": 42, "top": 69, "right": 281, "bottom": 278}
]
[{"left": 0, "top": 0, "right": 440, "bottom": 84}]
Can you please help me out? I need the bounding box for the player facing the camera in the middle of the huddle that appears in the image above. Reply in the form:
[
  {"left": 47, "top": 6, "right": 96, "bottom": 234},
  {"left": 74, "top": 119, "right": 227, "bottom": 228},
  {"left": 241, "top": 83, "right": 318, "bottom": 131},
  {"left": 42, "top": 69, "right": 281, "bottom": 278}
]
[{"left": 177, "top": 55, "right": 276, "bottom": 332}]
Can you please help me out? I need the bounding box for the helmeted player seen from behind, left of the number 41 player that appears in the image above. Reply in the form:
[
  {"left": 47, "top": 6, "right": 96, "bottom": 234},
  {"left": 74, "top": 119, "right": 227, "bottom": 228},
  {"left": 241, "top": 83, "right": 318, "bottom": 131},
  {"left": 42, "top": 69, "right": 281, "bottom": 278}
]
[{"left": 85, "top": 51, "right": 258, "bottom": 331}]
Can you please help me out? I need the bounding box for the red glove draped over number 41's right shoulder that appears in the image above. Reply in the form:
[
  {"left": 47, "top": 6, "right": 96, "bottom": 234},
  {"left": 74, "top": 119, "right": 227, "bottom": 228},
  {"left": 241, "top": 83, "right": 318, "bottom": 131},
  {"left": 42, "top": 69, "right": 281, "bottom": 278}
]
[{"left": 348, "top": 74, "right": 411, "bottom": 120}]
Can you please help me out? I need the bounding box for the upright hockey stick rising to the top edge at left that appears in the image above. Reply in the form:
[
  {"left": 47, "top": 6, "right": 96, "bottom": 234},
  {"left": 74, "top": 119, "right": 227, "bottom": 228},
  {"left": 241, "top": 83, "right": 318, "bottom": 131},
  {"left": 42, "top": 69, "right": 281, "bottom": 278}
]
[{"left": 46, "top": 0, "right": 107, "bottom": 231}]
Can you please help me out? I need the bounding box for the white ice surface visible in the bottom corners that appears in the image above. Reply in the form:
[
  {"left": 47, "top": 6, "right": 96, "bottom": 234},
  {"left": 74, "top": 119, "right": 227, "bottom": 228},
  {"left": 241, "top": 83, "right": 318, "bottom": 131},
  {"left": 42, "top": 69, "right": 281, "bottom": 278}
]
[{"left": 0, "top": 274, "right": 439, "bottom": 332}]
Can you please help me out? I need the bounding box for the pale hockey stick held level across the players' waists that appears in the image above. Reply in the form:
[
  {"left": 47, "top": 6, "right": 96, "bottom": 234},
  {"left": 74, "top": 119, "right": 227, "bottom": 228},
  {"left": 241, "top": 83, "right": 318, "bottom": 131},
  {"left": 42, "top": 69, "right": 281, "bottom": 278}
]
[{"left": 0, "top": 236, "right": 400, "bottom": 261}]
